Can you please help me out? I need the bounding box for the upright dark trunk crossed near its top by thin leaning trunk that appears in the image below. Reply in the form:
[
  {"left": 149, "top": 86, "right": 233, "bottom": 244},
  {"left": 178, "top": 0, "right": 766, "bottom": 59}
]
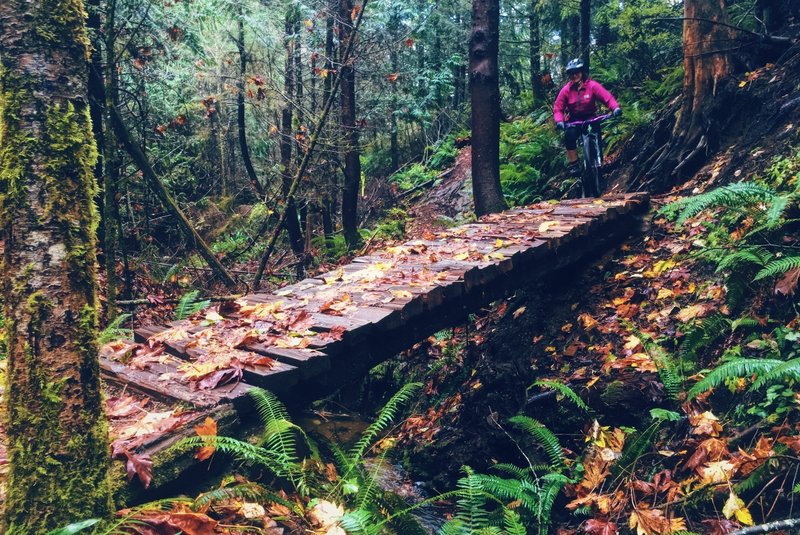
[{"left": 339, "top": 0, "right": 361, "bottom": 250}]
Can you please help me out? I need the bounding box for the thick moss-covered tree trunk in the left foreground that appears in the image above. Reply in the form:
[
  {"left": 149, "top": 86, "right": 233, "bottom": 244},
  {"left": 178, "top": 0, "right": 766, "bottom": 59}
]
[{"left": 0, "top": 0, "right": 111, "bottom": 534}]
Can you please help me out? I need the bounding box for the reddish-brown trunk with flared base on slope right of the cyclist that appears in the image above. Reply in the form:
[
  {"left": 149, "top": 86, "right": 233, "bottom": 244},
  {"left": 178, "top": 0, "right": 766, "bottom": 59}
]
[{"left": 647, "top": 0, "right": 731, "bottom": 180}]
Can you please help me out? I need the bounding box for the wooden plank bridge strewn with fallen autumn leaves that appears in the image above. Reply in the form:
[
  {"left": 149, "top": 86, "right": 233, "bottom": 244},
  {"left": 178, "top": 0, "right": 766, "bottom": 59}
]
[{"left": 101, "top": 194, "right": 648, "bottom": 498}]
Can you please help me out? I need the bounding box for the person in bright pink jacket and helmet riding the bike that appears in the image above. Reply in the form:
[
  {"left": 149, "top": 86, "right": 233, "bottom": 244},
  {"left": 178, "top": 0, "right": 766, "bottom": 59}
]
[{"left": 553, "top": 58, "right": 622, "bottom": 177}]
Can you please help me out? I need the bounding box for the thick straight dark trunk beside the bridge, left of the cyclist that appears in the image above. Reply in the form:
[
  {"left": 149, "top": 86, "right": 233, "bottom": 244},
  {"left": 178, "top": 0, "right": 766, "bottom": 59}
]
[{"left": 469, "top": 0, "right": 506, "bottom": 216}]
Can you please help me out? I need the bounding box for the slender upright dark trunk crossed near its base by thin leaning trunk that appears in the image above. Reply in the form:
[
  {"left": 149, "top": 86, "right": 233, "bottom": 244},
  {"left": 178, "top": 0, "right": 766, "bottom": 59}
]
[{"left": 280, "top": 13, "right": 303, "bottom": 268}]
